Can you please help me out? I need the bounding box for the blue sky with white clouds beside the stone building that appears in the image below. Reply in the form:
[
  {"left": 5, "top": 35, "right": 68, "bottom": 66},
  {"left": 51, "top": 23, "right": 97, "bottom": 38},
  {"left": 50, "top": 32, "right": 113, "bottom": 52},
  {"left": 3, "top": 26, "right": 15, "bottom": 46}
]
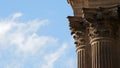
[{"left": 0, "top": 0, "right": 76, "bottom": 68}]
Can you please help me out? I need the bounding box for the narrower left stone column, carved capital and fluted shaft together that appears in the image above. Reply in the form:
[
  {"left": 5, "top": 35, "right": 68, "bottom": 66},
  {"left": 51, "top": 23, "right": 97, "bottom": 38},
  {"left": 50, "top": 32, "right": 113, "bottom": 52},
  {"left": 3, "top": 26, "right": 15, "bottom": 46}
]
[{"left": 68, "top": 16, "right": 87, "bottom": 68}]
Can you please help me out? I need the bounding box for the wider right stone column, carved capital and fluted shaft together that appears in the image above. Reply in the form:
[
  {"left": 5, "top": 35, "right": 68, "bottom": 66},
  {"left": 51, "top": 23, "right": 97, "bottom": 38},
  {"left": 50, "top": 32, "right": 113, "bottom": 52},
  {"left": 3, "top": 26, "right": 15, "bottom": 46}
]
[{"left": 83, "top": 7, "right": 118, "bottom": 68}]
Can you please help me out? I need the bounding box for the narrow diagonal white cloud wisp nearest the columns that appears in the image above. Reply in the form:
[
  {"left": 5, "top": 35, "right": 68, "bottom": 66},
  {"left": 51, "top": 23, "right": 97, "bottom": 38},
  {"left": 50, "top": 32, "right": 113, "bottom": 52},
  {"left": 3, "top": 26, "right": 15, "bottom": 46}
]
[{"left": 41, "top": 44, "right": 67, "bottom": 68}]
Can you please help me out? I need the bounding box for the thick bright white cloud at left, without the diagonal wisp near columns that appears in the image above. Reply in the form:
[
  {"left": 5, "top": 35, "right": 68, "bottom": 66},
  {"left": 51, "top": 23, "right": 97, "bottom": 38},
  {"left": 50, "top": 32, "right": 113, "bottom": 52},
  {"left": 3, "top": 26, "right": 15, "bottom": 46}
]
[{"left": 0, "top": 13, "right": 51, "bottom": 53}]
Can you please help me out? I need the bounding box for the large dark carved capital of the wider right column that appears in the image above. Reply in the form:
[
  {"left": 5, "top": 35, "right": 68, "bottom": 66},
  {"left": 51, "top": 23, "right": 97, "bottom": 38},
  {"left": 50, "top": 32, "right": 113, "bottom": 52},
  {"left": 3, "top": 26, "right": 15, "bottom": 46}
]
[{"left": 83, "top": 6, "right": 120, "bottom": 39}]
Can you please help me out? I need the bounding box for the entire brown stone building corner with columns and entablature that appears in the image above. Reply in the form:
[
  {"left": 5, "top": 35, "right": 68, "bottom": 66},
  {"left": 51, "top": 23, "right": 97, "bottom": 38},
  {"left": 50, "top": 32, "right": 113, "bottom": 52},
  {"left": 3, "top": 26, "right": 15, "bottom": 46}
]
[{"left": 68, "top": 0, "right": 120, "bottom": 68}]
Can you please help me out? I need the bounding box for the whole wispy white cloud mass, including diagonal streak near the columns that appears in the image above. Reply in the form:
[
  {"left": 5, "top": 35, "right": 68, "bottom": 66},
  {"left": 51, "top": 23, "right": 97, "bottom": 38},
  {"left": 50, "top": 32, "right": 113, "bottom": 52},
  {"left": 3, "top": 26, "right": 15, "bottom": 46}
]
[{"left": 0, "top": 13, "right": 73, "bottom": 68}]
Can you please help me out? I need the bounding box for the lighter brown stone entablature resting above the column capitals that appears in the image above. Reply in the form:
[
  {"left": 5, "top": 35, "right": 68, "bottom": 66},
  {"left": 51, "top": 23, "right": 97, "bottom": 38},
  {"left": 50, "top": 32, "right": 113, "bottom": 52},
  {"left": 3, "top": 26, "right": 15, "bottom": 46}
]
[{"left": 67, "top": 0, "right": 120, "bottom": 16}]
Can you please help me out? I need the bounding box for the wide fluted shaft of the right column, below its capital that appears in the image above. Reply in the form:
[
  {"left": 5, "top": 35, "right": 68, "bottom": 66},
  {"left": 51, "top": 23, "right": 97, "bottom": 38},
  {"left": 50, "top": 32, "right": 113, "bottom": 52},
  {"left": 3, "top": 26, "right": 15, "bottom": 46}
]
[{"left": 91, "top": 38, "right": 112, "bottom": 68}]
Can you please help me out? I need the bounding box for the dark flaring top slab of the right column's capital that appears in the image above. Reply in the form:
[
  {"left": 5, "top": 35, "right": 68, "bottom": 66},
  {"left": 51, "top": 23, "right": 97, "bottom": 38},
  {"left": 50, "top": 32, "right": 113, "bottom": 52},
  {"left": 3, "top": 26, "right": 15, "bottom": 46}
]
[{"left": 83, "top": 6, "right": 120, "bottom": 23}]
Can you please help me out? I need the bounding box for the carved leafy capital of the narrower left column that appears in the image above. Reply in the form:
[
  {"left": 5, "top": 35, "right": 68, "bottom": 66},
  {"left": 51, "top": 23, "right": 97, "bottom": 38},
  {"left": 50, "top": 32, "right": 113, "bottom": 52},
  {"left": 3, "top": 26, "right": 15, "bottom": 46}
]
[{"left": 68, "top": 16, "right": 87, "bottom": 51}]
